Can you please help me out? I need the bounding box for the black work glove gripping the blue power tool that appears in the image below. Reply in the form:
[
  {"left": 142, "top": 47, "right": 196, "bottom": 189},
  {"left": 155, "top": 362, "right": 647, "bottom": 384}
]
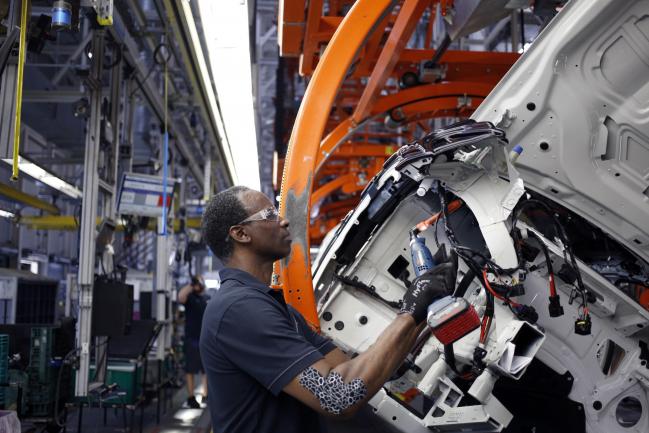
[{"left": 399, "top": 246, "right": 457, "bottom": 325}]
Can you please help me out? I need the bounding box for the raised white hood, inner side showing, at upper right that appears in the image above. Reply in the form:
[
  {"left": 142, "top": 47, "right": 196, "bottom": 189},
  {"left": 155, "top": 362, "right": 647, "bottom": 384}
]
[{"left": 473, "top": 0, "right": 649, "bottom": 260}]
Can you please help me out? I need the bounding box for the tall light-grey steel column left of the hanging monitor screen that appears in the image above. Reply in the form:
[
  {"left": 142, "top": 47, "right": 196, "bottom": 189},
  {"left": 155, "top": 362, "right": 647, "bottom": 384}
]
[{"left": 75, "top": 30, "right": 104, "bottom": 397}]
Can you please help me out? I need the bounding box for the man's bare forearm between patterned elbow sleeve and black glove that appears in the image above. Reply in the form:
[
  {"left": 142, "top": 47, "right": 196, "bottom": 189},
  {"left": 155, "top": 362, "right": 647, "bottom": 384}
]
[{"left": 333, "top": 314, "right": 422, "bottom": 397}]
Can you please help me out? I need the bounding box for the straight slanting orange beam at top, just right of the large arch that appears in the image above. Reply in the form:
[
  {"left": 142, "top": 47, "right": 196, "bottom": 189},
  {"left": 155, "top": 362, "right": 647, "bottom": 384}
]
[{"left": 352, "top": 0, "right": 430, "bottom": 124}]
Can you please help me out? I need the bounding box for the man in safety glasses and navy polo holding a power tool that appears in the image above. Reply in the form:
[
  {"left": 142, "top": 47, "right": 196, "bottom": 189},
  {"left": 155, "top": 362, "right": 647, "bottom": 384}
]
[{"left": 200, "top": 186, "right": 455, "bottom": 433}]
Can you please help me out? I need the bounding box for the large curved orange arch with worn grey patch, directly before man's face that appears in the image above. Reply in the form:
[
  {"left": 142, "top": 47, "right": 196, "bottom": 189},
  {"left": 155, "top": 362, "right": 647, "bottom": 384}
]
[{"left": 273, "top": 0, "right": 395, "bottom": 328}]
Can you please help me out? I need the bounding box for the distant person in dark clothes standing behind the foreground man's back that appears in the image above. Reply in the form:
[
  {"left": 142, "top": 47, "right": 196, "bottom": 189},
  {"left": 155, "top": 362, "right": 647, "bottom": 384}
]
[{"left": 178, "top": 276, "right": 209, "bottom": 409}]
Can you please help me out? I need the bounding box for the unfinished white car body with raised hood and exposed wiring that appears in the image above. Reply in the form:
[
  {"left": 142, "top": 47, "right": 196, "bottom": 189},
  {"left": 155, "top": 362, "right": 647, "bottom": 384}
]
[{"left": 314, "top": 0, "right": 649, "bottom": 433}]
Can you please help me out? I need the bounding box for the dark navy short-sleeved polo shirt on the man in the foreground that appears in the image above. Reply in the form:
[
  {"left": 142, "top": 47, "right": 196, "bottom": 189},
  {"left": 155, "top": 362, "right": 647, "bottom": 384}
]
[{"left": 200, "top": 268, "right": 335, "bottom": 433}]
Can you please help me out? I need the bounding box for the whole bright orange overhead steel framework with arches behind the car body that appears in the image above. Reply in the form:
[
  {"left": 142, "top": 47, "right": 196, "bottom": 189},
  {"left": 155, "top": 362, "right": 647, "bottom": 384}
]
[{"left": 274, "top": 0, "right": 519, "bottom": 328}]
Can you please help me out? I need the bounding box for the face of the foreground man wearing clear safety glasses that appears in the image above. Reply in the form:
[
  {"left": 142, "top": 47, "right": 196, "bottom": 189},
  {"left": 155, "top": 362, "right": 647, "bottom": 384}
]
[{"left": 241, "top": 191, "right": 291, "bottom": 261}]
